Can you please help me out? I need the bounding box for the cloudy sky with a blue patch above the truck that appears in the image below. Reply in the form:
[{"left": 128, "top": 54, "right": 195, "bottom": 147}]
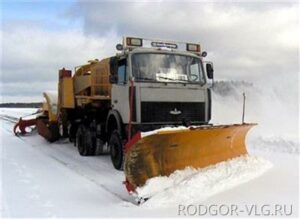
[{"left": 0, "top": 1, "right": 300, "bottom": 102}]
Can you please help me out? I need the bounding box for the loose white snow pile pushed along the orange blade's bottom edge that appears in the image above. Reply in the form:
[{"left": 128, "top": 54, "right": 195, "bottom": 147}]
[{"left": 136, "top": 155, "right": 272, "bottom": 208}]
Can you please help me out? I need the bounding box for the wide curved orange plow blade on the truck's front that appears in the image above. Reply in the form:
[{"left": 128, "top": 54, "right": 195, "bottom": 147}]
[{"left": 124, "top": 124, "right": 256, "bottom": 192}]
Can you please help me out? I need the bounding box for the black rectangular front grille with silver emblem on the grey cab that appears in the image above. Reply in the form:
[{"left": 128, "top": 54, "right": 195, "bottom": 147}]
[{"left": 141, "top": 102, "right": 205, "bottom": 123}]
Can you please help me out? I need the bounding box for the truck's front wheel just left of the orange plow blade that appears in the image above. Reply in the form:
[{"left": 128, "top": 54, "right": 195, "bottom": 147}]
[{"left": 109, "top": 130, "right": 124, "bottom": 170}]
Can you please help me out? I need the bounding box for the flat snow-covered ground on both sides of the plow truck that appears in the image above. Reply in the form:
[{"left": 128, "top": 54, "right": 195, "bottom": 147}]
[{"left": 0, "top": 108, "right": 299, "bottom": 217}]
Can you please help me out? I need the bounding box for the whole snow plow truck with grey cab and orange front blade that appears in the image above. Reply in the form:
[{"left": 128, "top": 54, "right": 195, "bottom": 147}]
[{"left": 14, "top": 37, "right": 255, "bottom": 192}]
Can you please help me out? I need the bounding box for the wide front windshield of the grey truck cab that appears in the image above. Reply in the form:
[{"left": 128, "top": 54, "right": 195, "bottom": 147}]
[{"left": 132, "top": 53, "right": 204, "bottom": 83}]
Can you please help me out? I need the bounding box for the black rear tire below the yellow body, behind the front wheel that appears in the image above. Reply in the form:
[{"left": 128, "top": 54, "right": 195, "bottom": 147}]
[{"left": 76, "top": 125, "right": 96, "bottom": 156}]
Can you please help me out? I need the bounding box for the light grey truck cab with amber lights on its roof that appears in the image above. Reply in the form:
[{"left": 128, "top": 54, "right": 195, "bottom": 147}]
[{"left": 107, "top": 37, "right": 213, "bottom": 167}]
